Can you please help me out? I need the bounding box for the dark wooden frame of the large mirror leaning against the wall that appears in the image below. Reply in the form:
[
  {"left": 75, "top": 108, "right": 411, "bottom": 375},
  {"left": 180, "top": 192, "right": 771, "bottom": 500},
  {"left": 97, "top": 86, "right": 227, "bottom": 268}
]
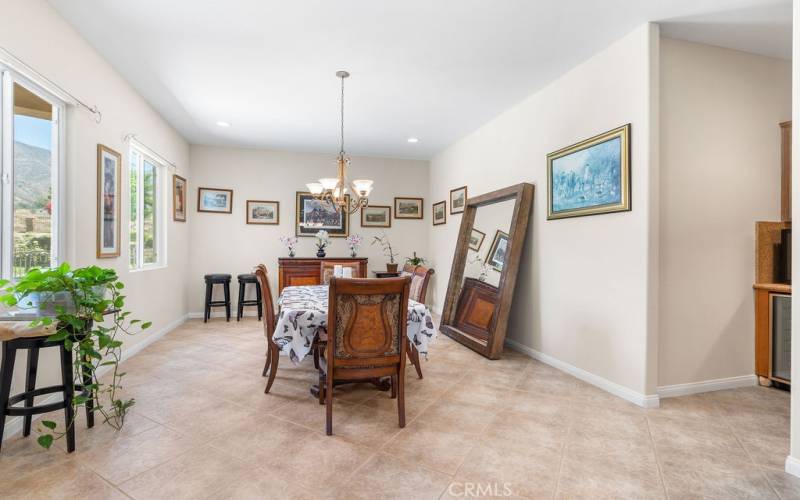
[{"left": 439, "top": 182, "right": 534, "bottom": 359}]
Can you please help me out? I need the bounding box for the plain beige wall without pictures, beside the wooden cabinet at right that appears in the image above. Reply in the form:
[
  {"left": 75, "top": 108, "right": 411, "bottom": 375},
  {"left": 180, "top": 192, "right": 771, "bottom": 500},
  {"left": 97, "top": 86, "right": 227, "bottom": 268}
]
[{"left": 658, "top": 39, "right": 792, "bottom": 386}]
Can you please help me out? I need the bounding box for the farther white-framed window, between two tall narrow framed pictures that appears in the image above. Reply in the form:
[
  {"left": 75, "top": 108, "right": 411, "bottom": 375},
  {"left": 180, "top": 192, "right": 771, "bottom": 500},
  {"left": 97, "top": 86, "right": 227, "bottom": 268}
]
[{"left": 129, "top": 146, "right": 167, "bottom": 270}]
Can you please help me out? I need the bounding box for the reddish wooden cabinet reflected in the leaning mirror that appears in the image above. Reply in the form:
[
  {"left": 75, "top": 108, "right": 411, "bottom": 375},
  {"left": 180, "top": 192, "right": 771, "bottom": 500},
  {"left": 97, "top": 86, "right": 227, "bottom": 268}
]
[{"left": 454, "top": 278, "right": 499, "bottom": 340}]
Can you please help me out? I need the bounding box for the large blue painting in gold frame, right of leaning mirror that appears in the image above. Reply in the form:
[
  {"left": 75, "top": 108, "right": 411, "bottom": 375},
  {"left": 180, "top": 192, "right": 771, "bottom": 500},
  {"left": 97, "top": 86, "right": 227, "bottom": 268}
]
[{"left": 547, "top": 124, "right": 631, "bottom": 220}]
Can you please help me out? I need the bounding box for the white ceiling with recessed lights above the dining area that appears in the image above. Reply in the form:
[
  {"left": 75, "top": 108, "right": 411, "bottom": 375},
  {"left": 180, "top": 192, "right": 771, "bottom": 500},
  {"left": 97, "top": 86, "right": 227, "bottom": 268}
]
[{"left": 49, "top": 0, "right": 791, "bottom": 158}]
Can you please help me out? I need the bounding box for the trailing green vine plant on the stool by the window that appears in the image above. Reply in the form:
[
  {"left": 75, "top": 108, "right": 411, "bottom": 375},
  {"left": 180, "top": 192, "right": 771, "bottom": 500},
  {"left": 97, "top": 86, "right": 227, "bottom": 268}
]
[{"left": 0, "top": 263, "right": 150, "bottom": 448}]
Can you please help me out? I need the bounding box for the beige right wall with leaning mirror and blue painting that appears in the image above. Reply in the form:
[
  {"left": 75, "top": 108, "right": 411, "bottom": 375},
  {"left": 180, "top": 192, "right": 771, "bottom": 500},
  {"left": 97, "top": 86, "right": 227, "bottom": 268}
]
[{"left": 430, "top": 25, "right": 658, "bottom": 396}]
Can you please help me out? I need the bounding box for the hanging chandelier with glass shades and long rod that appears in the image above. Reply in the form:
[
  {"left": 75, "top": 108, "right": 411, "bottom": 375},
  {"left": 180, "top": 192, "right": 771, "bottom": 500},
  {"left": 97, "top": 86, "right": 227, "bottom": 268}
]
[{"left": 306, "top": 71, "right": 372, "bottom": 214}]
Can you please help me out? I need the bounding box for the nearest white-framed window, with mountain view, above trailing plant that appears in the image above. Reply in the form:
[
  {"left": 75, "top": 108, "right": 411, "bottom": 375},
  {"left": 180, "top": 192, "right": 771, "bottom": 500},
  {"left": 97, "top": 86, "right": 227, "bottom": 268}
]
[{"left": 0, "top": 65, "right": 64, "bottom": 279}]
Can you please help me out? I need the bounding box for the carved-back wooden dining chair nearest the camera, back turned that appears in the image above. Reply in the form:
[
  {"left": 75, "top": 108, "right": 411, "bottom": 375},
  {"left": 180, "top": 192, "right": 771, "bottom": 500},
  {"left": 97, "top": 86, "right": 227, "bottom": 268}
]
[{"left": 319, "top": 277, "right": 411, "bottom": 436}]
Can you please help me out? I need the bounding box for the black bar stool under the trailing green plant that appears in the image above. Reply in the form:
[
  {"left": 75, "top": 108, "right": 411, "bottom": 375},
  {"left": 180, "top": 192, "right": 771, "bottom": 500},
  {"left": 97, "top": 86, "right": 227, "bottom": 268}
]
[{"left": 0, "top": 321, "right": 94, "bottom": 453}]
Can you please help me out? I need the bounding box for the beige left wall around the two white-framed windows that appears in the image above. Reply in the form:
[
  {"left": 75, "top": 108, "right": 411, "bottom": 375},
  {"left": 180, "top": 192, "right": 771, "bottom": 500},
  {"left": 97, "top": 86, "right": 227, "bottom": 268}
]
[{"left": 0, "top": 0, "right": 191, "bottom": 418}]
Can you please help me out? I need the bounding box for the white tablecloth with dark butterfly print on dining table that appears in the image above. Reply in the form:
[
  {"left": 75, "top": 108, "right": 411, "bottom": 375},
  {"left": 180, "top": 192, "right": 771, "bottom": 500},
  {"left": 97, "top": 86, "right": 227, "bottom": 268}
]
[{"left": 272, "top": 285, "right": 436, "bottom": 364}]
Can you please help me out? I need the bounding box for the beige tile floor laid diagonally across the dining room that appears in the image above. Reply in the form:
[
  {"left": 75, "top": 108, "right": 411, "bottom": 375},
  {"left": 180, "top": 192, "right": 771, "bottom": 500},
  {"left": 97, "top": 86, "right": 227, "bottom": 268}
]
[{"left": 0, "top": 319, "right": 800, "bottom": 500}]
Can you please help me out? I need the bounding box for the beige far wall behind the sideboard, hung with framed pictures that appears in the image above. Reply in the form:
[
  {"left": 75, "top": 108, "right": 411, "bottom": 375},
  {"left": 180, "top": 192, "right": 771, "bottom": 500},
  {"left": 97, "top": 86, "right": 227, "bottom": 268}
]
[{"left": 188, "top": 146, "right": 431, "bottom": 312}]
